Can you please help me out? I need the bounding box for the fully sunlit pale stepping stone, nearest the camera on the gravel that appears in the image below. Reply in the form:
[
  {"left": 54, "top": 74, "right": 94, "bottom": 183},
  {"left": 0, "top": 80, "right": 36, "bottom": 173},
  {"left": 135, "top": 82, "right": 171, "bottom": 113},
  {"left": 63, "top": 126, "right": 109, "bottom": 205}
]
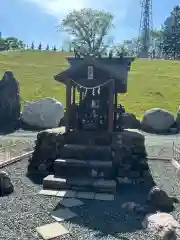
[{"left": 36, "top": 222, "right": 69, "bottom": 240}]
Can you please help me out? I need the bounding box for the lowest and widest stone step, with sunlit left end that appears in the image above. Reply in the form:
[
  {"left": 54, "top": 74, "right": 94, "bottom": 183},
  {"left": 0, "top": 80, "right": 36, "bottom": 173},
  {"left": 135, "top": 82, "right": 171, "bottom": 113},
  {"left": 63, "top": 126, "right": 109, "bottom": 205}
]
[{"left": 43, "top": 175, "right": 116, "bottom": 193}]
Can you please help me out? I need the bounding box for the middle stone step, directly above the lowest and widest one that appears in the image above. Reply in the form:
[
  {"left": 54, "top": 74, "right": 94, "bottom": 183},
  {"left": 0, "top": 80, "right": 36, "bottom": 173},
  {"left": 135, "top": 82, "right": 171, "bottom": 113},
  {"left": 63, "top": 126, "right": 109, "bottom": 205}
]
[{"left": 53, "top": 159, "right": 112, "bottom": 177}]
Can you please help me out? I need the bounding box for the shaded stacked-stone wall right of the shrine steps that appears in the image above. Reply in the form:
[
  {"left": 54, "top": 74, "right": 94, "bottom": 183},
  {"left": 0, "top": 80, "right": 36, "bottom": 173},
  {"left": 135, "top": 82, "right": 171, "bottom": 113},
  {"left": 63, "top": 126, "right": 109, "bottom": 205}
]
[{"left": 112, "top": 130, "right": 151, "bottom": 182}]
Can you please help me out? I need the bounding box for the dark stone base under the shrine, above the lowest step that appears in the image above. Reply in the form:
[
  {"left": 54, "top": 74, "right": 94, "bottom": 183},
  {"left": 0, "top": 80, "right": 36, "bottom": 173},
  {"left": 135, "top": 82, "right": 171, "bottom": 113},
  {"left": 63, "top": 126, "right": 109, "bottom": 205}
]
[{"left": 28, "top": 128, "right": 151, "bottom": 187}]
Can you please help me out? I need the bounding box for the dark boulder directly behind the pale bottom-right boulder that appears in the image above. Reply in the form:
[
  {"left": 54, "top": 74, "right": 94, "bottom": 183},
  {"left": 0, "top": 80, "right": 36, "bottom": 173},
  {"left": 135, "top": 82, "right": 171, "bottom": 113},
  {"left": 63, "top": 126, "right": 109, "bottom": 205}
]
[{"left": 147, "top": 186, "right": 179, "bottom": 212}]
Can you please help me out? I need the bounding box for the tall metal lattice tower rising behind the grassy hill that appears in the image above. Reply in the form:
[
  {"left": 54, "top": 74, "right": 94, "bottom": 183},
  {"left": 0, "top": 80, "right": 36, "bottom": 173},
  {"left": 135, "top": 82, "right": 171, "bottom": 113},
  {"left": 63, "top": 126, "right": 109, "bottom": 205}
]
[{"left": 138, "top": 0, "right": 153, "bottom": 58}]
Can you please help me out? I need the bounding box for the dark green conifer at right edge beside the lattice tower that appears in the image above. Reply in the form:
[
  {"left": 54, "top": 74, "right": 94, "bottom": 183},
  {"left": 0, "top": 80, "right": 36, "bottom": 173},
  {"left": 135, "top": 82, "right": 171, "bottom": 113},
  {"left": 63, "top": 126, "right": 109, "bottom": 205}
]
[{"left": 162, "top": 6, "right": 180, "bottom": 59}]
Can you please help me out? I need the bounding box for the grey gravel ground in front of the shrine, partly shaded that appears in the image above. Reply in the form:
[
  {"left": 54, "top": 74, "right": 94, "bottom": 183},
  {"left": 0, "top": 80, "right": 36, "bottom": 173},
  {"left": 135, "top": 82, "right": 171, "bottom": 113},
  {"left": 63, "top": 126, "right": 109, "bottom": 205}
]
[{"left": 0, "top": 160, "right": 180, "bottom": 240}]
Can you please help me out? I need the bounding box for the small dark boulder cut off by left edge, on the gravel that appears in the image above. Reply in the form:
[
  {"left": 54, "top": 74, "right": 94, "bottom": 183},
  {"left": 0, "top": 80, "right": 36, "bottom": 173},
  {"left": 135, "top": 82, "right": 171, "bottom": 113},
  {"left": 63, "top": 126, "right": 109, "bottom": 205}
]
[{"left": 0, "top": 171, "right": 14, "bottom": 196}]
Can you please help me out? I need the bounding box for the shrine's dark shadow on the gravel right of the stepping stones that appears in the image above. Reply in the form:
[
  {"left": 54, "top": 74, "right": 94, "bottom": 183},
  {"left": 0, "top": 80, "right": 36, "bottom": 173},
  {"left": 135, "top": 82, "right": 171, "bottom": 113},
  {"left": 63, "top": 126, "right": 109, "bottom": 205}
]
[{"left": 56, "top": 179, "right": 154, "bottom": 237}]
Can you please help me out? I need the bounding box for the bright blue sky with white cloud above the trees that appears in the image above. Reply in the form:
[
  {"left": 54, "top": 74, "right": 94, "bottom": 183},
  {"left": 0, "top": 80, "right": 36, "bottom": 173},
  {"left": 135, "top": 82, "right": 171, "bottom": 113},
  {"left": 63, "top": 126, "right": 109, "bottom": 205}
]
[{"left": 0, "top": 0, "right": 179, "bottom": 47}]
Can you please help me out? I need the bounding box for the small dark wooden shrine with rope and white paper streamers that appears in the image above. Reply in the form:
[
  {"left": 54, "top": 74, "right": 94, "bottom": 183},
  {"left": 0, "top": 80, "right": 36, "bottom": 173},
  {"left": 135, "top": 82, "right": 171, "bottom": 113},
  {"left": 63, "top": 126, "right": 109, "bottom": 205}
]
[{"left": 54, "top": 56, "right": 133, "bottom": 132}]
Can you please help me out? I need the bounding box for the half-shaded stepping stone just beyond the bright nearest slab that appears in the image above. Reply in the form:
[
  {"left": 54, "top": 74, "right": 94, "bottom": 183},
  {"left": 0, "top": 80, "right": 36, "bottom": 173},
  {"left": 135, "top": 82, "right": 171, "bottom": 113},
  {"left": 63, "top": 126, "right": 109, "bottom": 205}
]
[{"left": 51, "top": 208, "right": 77, "bottom": 222}]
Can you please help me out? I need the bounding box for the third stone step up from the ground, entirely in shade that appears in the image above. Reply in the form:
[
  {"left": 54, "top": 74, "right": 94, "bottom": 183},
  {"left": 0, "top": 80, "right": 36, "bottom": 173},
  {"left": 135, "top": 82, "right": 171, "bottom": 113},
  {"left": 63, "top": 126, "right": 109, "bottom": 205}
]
[{"left": 60, "top": 144, "right": 111, "bottom": 161}]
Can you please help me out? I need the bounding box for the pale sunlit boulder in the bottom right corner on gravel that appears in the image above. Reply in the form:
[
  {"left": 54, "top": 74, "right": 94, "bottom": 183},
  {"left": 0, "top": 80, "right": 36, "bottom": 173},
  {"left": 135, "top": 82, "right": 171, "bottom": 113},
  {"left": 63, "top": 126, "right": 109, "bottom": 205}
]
[{"left": 142, "top": 212, "right": 180, "bottom": 240}]
